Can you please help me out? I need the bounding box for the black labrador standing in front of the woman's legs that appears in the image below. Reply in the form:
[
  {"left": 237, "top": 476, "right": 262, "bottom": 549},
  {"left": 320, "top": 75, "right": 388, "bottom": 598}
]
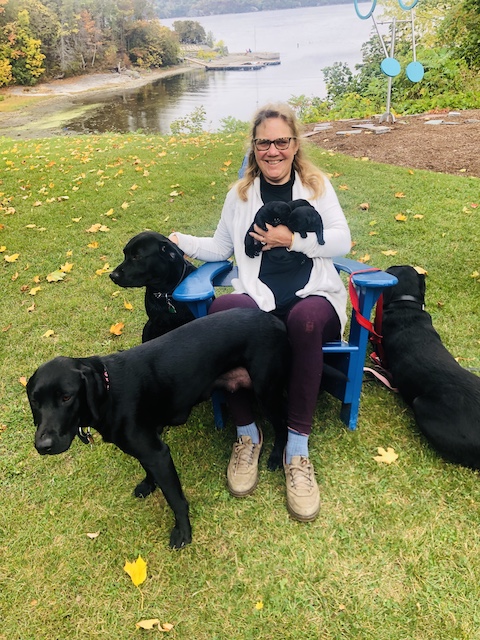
[{"left": 27, "top": 309, "right": 289, "bottom": 548}]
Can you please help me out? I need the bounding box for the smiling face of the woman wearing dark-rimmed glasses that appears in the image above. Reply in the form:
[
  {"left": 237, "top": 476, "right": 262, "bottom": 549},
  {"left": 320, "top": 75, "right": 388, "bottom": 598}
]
[{"left": 255, "top": 118, "right": 298, "bottom": 184}]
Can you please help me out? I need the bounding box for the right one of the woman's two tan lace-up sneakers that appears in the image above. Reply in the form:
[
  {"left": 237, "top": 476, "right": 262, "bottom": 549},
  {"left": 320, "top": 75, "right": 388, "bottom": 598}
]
[{"left": 283, "top": 456, "right": 320, "bottom": 522}]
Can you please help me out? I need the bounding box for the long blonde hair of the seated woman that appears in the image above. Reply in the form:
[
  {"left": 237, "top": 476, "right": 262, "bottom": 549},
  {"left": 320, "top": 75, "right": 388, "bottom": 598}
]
[{"left": 237, "top": 103, "right": 325, "bottom": 202}]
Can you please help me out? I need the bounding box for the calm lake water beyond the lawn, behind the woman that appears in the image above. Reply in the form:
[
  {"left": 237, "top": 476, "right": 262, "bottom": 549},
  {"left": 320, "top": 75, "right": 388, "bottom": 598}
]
[{"left": 67, "top": 2, "right": 372, "bottom": 133}]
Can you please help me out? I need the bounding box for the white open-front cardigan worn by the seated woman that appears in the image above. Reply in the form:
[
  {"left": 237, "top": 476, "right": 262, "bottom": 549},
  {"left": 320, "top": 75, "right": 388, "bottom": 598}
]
[{"left": 175, "top": 174, "right": 351, "bottom": 333}]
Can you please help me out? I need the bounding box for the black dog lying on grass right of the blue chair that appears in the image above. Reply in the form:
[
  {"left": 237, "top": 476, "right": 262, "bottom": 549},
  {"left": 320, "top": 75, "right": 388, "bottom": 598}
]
[{"left": 382, "top": 266, "right": 480, "bottom": 469}]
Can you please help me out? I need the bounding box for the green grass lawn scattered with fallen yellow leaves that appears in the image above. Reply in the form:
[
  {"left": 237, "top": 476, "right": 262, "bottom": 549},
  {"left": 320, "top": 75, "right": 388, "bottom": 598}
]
[{"left": 0, "top": 135, "right": 480, "bottom": 640}]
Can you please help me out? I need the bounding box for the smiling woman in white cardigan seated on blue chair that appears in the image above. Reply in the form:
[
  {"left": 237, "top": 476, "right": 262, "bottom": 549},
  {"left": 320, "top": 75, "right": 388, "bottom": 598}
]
[{"left": 170, "top": 104, "right": 351, "bottom": 521}]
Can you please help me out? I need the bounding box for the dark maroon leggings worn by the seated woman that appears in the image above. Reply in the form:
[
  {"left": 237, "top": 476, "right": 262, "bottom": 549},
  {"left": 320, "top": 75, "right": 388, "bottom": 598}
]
[{"left": 208, "top": 293, "right": 340, "bottom": 435}]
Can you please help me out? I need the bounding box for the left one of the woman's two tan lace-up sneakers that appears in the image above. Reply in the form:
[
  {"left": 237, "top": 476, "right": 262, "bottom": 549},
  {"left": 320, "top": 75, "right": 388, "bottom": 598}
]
[{"left": 227, "top": 429, "right": 263, "bottom": 498}]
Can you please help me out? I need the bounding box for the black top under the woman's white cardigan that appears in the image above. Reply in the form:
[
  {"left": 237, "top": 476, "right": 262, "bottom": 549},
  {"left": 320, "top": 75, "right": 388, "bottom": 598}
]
[{"left": 259, "top": 171, "right": 313, "bottom": 315}]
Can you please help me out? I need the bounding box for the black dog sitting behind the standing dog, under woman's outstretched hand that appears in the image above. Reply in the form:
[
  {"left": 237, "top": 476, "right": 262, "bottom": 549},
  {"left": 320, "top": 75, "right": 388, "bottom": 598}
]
[{"left": 110, "top": 231, "right": 196, "bottom": 342}]
